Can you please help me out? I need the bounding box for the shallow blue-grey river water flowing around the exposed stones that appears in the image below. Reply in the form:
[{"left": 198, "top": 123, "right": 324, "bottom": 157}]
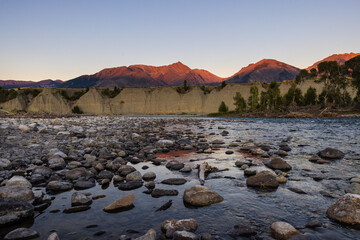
[{"left": 3, "top": 117, "right": 360, "bottom": 239}]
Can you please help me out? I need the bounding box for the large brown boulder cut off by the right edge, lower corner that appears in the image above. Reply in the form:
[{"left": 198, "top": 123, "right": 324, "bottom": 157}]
[{"left": 326, "top": 193, "right": 360, "bottom": 227}]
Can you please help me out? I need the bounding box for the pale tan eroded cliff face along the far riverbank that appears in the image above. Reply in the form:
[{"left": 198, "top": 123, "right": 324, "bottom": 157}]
[{"left": 0, "top": 80, "right": 356, "bottom": 115}]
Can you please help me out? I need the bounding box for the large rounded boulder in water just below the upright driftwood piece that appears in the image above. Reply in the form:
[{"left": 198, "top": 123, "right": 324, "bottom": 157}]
[{"left": 183, "top": 185, "right": 224, "bottom": 207}]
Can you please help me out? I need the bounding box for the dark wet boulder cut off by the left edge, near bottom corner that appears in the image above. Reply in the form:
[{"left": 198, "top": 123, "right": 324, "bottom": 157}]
[{"left": 0, "top": 198, "right": 34, "bottom": 226}]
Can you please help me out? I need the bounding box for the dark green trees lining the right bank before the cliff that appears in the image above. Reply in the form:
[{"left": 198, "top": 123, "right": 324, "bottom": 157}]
[{"left": 225, "top": 55, "right": 360, "bottom": 112}]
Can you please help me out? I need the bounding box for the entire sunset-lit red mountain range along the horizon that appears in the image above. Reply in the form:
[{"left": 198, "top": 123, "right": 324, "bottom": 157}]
[{"left": 0, "top": 53, "right": 360, "bottom": 88}]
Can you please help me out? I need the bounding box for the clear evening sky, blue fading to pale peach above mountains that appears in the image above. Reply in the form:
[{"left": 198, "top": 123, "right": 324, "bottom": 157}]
[{"left": 0, "top": 0, "right": 360, "bottom": 81}]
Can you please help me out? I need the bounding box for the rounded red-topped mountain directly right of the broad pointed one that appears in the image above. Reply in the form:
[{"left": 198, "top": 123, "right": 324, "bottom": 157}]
[{"left": 226, "top": 59, "right": 300, "bottom": 83}]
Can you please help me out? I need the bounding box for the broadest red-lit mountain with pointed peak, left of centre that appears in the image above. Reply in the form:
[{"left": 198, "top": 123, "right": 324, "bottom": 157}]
[{"left": 61, "top": 62, "right": 223, "bottom": 88}]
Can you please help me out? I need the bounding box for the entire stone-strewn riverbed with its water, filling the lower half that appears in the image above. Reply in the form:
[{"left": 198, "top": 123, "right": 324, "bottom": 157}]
[{"left": 0, "top": 116, "right": 360, "bottom": 239}]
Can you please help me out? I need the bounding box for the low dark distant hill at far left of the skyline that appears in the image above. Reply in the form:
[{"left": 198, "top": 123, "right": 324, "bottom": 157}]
[{"left": 0, "top": 79, "right": 63, "bottom": 89}]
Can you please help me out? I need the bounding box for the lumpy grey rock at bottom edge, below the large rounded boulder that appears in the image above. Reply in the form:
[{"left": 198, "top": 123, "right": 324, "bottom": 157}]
[{"left": 161, "top": 218, "right": 198, "bottom": 238}]
